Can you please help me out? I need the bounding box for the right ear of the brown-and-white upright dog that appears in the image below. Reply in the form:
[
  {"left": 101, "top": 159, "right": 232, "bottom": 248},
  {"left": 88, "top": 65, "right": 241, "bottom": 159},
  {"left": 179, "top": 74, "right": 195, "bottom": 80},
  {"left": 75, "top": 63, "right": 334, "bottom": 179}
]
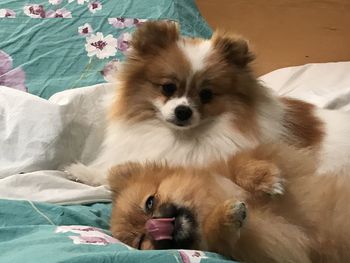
[{"left": 212, "top": 31, "right": 255, "bottom": 68}]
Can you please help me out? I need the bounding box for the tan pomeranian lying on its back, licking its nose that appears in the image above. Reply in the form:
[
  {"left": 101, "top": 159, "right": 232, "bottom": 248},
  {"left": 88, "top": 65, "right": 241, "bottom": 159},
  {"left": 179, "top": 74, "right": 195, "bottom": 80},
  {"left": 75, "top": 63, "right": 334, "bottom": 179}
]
[{"left": 109, "top": 145, "right": 350, "bottom": 263}]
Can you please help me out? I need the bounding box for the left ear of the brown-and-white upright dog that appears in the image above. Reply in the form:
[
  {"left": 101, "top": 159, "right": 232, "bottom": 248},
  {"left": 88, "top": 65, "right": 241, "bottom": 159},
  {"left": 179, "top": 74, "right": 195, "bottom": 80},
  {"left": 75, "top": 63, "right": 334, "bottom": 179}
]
[{"left": 131, "top": 21, "right": 180, "bottom": 54}]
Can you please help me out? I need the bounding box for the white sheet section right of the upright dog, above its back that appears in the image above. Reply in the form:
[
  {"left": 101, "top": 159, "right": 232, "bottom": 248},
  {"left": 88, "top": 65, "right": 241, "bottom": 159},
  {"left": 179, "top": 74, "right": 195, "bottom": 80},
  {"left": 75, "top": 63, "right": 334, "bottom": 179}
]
[{"left": 260, "top": 62, "right": 350, "bottom": 111}]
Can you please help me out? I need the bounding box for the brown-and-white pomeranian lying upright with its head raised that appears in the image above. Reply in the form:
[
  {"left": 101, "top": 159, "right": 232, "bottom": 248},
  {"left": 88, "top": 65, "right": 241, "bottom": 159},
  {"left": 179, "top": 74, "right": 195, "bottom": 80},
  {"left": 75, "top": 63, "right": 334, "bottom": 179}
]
[{"left": 67, "top": 22, "right": 350, "bottom": 185}]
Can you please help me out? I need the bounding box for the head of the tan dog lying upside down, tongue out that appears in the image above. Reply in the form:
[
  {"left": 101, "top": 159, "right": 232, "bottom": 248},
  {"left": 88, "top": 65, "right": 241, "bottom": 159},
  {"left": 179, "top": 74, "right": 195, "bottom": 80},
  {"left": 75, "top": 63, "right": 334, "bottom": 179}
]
[{"left": 109, "top": 163, "right": 245, "bottom": 252}]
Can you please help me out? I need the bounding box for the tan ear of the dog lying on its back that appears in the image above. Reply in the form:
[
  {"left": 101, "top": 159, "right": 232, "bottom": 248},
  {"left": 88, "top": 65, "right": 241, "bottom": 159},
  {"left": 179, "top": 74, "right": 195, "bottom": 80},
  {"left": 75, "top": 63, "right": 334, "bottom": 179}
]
[{"left": 108, "top": 162, "right": 142, "bottom": 194}]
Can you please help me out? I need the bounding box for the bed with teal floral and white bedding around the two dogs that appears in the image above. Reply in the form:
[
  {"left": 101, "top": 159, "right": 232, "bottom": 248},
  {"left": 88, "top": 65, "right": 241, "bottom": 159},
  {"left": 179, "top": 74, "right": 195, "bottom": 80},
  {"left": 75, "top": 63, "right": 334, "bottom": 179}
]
[{"left": 0, "top": 0, "right": 350, "bottom": 263}]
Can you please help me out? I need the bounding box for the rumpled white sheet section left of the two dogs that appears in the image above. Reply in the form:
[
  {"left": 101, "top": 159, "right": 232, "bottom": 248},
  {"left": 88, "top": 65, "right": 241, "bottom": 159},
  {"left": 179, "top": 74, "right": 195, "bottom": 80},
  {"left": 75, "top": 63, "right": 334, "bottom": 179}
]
[{"left": 0, "top": 84, "right": 114, "bottom": 204}]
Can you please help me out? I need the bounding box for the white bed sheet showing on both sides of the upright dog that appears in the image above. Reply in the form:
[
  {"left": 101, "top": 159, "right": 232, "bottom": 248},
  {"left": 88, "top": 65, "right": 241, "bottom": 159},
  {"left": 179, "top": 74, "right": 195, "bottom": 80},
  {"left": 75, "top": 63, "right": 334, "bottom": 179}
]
[{"left": 0, "top": 62, "right": 350, "bottom": 204}]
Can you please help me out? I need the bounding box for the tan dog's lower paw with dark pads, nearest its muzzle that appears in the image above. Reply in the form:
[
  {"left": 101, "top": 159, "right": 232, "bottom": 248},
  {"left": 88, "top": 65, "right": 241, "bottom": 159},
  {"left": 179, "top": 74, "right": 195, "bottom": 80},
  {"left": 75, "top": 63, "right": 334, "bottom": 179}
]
[{"left": 223, "top": 200, "right": 247, "bottom": 229}]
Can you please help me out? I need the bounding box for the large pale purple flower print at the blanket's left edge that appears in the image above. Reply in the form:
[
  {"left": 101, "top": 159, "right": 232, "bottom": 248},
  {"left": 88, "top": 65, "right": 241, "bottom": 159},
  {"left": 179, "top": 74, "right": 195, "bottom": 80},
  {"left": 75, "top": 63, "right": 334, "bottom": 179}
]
[{"left": 0, "top": 50, "right": 27, "bottom": 91}]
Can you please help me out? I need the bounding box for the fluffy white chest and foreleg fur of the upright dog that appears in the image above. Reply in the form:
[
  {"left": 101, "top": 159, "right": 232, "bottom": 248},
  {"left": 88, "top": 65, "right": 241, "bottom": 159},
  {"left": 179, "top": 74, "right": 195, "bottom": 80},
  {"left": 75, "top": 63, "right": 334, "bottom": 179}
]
[{"left": 68, "top": 115, "right": 258, "bottom": 185}]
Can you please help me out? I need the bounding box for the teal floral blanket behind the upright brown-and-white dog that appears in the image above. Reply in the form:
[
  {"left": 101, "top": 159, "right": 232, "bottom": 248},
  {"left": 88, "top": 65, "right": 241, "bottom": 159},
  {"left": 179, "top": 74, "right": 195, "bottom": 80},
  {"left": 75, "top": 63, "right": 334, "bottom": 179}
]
[{"left": 0, "top": 0, "right": 211, "bottom": 98}]
